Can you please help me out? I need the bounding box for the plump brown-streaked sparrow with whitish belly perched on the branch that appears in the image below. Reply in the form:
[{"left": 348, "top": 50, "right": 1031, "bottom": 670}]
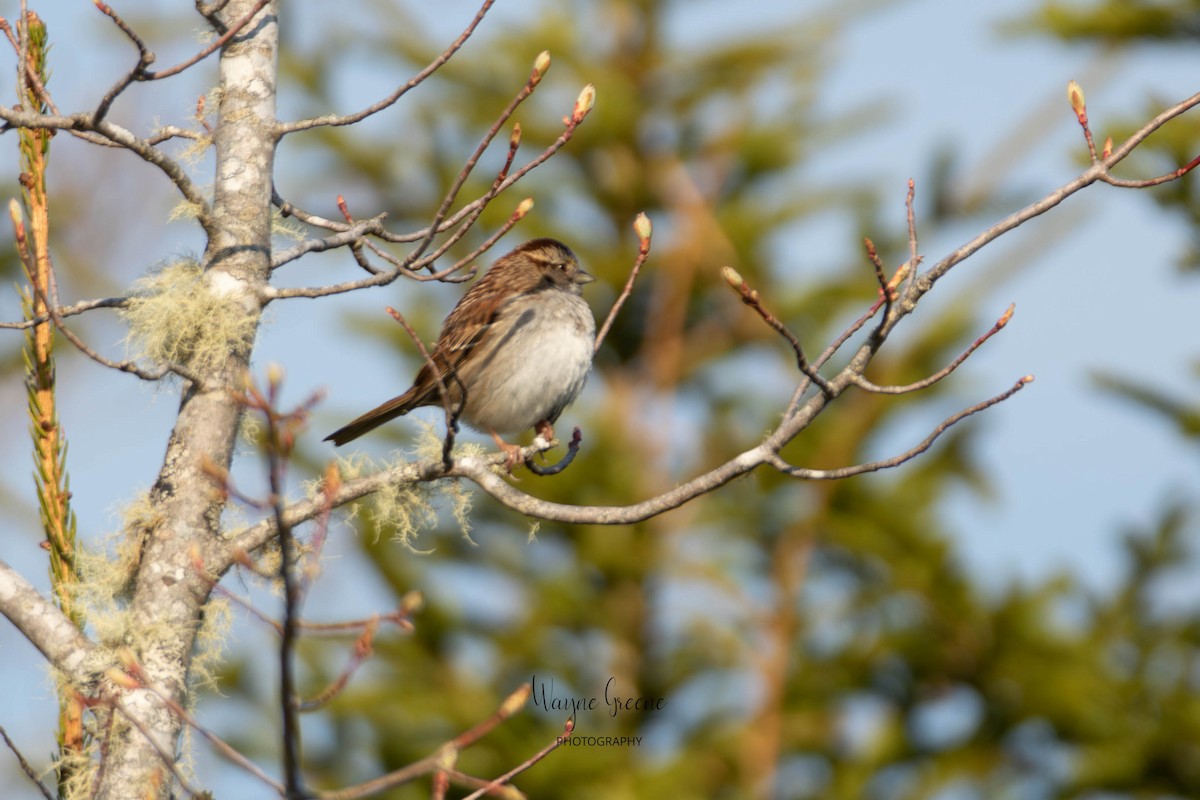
[{"left": 325, "top": 239, "right": 595, "bottom": 459}]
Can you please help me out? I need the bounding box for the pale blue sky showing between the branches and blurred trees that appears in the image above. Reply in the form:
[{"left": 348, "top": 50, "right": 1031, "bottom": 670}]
[{"left": 0, "top": 0, "right": 1200, "bottom": 796}]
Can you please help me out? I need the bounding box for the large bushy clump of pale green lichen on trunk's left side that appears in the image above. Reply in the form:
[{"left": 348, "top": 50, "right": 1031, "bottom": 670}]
[{"left": 121, "top": 259, "right": 256, "bottom": 372}]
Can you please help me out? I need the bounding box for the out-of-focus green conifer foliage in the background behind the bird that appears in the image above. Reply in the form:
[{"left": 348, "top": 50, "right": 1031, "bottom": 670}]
[{"left": 206, "top": 0, "right": 1200, "bottom": 799}]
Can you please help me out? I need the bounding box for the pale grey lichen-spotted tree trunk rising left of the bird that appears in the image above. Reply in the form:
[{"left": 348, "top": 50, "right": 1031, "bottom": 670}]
[{"left": 96, "top": 0, "right": 278, "bottom": 800}]
